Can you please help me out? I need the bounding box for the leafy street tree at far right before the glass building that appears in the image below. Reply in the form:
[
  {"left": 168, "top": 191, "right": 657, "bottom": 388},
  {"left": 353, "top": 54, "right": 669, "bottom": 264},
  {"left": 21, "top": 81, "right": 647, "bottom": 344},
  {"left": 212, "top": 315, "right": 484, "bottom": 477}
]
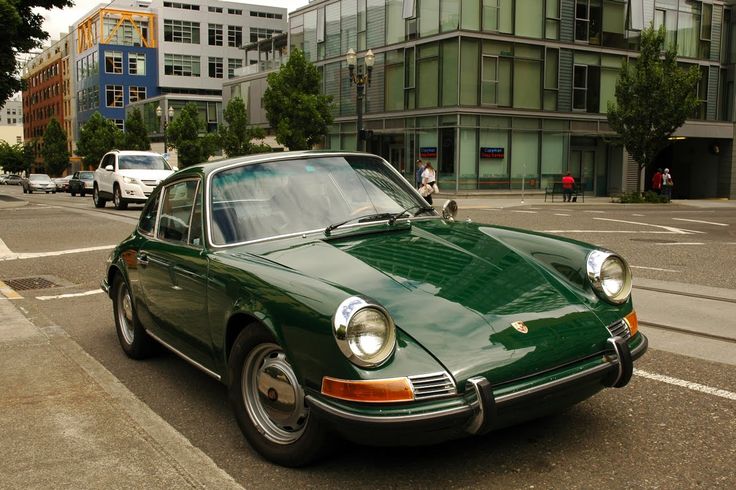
[{"left": 608, "top": 25, "right": 700, "bottom": 190}]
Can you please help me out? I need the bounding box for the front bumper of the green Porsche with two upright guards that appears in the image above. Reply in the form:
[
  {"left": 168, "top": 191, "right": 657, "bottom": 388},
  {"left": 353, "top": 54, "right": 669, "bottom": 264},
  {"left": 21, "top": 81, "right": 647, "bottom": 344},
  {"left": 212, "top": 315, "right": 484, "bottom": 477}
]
[{"left": 306, "top": 333, "right": 648, "bottom": 445}]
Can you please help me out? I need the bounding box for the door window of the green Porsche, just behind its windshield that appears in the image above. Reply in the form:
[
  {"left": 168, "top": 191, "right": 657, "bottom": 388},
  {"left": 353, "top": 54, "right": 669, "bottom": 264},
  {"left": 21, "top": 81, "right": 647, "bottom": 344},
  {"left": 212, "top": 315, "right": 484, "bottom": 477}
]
[{"left": 156, "top": 180, "right": 198, "bottom": 243}]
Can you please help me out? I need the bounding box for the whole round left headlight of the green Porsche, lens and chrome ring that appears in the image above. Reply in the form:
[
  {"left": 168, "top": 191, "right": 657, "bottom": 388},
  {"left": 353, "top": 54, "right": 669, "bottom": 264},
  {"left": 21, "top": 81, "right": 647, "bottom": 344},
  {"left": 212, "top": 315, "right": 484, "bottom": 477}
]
[{"left": 332, "top": 296, "right": 396, "bottom": 367}]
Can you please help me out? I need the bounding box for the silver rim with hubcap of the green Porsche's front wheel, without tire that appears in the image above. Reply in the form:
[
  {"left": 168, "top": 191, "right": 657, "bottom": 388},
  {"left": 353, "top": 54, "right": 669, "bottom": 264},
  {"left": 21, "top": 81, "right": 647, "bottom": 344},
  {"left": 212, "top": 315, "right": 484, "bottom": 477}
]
[{"left": 241, "top": 344, "right": 309, "bottom": 444}]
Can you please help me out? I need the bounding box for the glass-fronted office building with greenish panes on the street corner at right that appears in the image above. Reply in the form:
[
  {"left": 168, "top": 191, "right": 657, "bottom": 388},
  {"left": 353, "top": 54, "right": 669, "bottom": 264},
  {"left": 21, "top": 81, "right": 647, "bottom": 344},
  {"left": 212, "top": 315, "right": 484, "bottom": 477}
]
[{"left": 230, "top": 0, "right": 736, "bottom": 198}]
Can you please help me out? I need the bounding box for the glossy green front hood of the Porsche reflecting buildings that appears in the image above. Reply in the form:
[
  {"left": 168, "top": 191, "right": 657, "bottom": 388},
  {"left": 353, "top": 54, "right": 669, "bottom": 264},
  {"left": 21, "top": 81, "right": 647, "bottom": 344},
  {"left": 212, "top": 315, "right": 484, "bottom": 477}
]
[{"left": 250, "top": 220, "right": 609, "bottom": 384}]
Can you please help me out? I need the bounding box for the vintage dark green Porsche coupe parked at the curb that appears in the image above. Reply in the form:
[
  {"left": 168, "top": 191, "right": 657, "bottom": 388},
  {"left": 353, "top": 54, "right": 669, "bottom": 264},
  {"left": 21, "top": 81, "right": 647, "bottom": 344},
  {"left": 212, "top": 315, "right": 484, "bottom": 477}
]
[{"left": 103, "top": 151, "right": 647, "bottom": 466}]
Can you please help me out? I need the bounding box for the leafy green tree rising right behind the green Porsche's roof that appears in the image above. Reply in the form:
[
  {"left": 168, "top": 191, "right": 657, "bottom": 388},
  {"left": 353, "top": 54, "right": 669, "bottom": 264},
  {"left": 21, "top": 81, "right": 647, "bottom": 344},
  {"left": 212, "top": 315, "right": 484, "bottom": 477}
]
[{"left": 262, "top": 49, "right": 332, "bottom": 150}]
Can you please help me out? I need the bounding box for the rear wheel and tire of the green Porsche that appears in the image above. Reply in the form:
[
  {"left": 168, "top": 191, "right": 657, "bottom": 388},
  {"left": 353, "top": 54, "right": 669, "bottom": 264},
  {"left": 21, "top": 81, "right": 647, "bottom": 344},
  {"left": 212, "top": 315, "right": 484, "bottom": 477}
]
[{"left": 112, "top": 274, "right": 155, "bottom": 359}]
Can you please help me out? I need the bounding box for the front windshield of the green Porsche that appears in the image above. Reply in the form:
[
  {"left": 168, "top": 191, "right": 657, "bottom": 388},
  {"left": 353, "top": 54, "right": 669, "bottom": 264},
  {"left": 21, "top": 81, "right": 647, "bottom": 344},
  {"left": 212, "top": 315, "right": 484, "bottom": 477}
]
[{"left": 210, "top": 155, "right": 428, "bottom": 245}]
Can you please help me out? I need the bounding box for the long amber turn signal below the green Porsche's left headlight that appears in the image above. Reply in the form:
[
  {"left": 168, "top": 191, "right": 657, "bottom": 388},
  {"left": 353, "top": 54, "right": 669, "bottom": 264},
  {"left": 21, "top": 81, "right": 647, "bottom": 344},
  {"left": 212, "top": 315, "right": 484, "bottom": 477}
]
[{"left": 322, "top": 376, "right": 414, "bottom": 403}]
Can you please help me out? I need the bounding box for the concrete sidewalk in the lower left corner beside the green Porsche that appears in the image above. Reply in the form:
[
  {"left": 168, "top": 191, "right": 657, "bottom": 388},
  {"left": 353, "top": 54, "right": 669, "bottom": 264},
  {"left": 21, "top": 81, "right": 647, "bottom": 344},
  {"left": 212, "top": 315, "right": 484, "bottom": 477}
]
[{"left": 0, "top": 295, "right": 242, "bottom": 489}]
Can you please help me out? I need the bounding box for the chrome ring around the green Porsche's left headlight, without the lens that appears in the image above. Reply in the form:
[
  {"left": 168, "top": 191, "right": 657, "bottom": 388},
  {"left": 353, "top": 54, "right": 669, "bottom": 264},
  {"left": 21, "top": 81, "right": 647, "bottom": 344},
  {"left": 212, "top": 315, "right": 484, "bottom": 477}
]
[{"left": 332, "top": 296, "right": 396, "bottom": 368}]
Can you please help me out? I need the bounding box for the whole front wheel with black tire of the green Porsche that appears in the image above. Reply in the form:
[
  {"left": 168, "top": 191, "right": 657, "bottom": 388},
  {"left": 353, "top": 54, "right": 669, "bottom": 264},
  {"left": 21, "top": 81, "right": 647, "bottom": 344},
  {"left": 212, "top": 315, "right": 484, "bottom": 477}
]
[{"left": 228, "top": 324, "right": 329, "bottom": 467}]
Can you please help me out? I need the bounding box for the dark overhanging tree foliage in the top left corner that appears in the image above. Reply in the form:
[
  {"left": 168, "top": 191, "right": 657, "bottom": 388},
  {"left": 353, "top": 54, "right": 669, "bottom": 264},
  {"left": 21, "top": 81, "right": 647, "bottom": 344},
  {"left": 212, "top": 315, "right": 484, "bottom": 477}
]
[{"left": 0, "top": 0, "right": 74, "bottom": 106}]
